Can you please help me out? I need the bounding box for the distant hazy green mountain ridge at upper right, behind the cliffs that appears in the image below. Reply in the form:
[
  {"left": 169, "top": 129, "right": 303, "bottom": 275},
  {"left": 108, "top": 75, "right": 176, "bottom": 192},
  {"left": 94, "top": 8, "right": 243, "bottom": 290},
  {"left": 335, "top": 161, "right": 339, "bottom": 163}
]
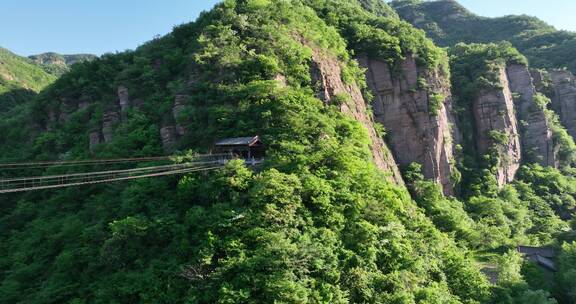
[{"left": 390, "top": 0, "right": 576, "bottom": 72}]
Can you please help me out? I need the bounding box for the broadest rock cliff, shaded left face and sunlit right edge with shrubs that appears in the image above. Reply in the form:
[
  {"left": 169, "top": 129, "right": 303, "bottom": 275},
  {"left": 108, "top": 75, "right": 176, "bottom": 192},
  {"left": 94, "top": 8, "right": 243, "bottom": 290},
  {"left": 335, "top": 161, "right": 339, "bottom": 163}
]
[{"left": 359, "top": 57, "right": 456, "bottom": 194}]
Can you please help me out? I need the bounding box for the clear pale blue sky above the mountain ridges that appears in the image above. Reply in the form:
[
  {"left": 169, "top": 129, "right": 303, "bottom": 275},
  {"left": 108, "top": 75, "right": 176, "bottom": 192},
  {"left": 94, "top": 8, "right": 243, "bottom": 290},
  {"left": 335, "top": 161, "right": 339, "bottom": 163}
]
[{"left": 0, "top": 0, "right": 576, "bottom": 55}]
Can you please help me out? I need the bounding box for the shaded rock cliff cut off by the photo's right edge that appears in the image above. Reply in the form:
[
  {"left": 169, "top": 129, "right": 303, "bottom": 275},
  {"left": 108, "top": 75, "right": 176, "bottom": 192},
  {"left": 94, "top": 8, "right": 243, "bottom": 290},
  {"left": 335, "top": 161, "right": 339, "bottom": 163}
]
[{"left": 550, "top": 70, "right": 576, "bottom": 138}]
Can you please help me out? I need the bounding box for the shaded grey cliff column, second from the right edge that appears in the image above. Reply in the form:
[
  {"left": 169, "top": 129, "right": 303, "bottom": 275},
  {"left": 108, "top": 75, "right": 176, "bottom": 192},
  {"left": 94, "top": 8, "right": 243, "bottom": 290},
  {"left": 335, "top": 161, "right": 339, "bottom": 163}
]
[{"left": 506, "top": 64, "right": 558, "bottom": 167}]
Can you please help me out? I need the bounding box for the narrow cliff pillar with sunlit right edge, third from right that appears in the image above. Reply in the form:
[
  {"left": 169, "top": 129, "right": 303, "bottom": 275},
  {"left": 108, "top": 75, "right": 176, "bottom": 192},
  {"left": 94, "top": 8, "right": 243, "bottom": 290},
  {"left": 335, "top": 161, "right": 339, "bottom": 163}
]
[{"left": 472, "top": 68, "right": 522, "bottom": 186}]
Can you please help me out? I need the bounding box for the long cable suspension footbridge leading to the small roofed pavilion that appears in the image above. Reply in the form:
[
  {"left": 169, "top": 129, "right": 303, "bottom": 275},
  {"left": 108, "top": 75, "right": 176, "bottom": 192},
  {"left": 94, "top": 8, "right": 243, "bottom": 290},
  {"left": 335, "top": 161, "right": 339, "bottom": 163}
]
[{"left": 0, "top": 154, "right": 262, "bottom": 194}]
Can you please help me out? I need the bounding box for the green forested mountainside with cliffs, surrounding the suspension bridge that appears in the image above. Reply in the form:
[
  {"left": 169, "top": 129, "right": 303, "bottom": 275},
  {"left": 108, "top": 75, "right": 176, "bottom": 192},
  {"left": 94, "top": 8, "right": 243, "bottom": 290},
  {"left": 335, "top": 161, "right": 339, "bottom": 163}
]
[{"left": 0, "top": 0, "right": 576, "bottom": 304}]
